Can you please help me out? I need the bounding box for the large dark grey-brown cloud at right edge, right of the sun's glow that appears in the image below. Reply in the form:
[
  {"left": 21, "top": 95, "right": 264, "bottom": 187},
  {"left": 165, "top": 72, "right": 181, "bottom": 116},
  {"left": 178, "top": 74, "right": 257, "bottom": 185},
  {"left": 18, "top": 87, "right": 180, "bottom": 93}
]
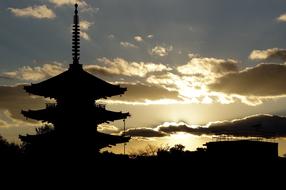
[{"left": 208, "top": 64, "right": 286, "bottom": 97}]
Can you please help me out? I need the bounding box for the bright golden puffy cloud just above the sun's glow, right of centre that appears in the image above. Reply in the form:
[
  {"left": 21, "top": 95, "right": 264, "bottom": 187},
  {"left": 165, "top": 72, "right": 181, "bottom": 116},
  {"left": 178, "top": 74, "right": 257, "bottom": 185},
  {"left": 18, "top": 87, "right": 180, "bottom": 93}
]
[{"left": 177, "top": 55, "right": 238, "bottom": 77}]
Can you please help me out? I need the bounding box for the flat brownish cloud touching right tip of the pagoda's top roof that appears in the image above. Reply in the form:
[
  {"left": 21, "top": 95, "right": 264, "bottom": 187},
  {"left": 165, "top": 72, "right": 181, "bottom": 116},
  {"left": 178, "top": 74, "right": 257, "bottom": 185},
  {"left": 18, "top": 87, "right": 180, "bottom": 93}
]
[{"left": 112, "top": 84, "right": 181, "bottom": 102}]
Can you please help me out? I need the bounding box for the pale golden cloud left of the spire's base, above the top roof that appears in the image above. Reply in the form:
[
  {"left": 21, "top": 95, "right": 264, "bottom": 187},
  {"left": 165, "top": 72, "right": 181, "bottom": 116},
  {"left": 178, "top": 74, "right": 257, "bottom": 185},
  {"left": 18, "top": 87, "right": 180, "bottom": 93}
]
[{"left": 2, "top": 62, "right": 65, "bottom": 81}]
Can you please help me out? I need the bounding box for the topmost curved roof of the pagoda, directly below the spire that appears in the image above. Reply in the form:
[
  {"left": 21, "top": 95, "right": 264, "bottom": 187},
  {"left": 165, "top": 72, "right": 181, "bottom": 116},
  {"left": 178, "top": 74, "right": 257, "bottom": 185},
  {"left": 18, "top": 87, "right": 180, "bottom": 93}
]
[{"left": 24, "top": 64, "right": 126, "bottom": 99}]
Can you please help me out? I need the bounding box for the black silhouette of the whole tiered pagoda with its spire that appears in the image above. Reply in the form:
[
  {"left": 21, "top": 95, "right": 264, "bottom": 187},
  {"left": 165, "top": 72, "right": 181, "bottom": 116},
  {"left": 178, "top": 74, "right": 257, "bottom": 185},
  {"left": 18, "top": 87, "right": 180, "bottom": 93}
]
[{"left": 19, "top": 4, "right": 130, "bottom": 157}]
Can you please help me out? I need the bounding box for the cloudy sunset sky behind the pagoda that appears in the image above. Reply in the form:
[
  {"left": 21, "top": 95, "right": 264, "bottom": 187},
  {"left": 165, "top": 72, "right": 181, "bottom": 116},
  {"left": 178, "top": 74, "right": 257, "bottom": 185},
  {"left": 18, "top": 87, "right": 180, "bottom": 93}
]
[{"left": 0, "top": 0, "right": 286, "bottom": 155}]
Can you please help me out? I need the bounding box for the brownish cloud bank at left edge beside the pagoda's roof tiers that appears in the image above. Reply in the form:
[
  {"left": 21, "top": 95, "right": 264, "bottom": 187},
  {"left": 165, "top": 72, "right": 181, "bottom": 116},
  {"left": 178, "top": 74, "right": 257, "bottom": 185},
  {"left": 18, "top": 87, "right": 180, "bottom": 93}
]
[{"left": 0, "top": 85, "right": 45, "bottom": 142}]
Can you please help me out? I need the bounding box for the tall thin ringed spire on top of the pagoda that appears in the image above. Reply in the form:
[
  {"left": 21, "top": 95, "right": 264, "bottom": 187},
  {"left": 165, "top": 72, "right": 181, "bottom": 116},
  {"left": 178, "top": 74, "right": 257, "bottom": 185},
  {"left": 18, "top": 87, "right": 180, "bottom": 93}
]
[{"left": 72, "top": 3, "right": 80, "bottom": 64}]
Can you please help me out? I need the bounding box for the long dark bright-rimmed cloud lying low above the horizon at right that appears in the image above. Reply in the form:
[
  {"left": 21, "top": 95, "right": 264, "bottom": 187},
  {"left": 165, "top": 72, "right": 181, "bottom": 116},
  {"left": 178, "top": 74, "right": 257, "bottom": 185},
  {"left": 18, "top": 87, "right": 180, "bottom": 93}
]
[{"left": 127, "top": 114, "right": 286, "bottom": 138}]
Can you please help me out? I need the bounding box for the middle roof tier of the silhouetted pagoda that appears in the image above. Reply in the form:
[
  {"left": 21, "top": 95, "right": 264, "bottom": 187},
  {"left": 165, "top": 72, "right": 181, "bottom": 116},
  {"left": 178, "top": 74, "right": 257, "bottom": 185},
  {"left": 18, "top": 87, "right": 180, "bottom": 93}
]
[{"left": 21, "top": 106, "right": 130, "bottom": 124}]
